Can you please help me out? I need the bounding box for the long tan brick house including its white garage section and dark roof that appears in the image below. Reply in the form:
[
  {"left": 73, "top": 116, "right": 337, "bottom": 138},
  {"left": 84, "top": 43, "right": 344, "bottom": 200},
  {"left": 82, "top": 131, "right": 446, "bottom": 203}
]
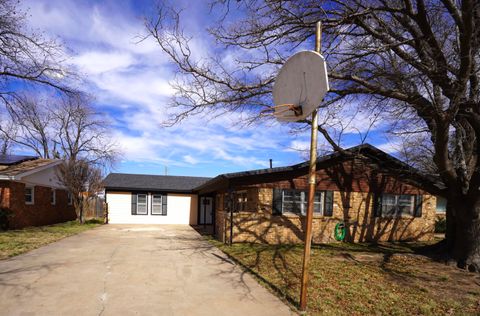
[{"left": 106, "top": 144, "right": 441, "bottom": 243}]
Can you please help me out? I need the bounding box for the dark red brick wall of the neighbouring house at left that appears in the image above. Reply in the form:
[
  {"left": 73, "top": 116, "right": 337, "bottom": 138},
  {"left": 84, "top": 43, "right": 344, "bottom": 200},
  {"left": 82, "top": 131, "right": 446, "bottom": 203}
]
[{"left": 0, "top": 181, "right": 76, "bottom": 229}]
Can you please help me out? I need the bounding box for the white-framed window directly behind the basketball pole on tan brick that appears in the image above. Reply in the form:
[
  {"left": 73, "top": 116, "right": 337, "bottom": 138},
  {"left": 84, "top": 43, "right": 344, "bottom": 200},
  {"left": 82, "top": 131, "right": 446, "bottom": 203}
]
[{"left": 282, "top": 190, "right": 325, "bottom": 215}]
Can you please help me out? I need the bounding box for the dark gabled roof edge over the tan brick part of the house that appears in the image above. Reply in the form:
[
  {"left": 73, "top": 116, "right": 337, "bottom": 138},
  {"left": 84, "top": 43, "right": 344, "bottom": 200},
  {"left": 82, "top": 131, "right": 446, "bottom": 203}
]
[{"left": 195, "top": 143, "right": 443, "bottom": 191}]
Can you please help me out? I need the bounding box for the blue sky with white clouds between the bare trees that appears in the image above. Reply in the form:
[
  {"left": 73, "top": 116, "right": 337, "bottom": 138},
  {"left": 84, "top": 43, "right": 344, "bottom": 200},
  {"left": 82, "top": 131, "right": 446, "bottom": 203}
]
[{"left": 21, "top": 0, "right": 395, "bottom": 176}]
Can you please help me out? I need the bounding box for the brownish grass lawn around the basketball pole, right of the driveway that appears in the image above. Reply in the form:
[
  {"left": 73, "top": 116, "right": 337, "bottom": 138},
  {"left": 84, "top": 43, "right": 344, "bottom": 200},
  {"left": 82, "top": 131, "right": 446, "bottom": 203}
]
[{"left": 211, "top": 240, "right": 480, "bottom": 315}]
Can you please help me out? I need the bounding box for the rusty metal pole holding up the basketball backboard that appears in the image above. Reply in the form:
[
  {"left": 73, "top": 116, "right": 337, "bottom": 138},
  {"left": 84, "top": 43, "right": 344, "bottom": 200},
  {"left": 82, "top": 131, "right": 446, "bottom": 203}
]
[{"left": 300, "top": 22, "right": 322, "bottom": 311}]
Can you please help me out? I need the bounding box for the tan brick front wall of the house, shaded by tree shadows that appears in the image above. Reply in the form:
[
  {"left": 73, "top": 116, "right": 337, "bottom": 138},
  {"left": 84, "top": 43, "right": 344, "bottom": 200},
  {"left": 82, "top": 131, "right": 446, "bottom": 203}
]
[{"left": 216, "top": 163, "right": 436, "bottom": 244}]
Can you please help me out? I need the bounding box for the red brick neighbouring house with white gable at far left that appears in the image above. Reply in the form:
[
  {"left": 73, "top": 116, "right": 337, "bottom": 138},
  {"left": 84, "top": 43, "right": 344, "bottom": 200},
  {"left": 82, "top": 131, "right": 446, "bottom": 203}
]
[{"left": 0, "top": 155, "right": 76, "bottom": 229}]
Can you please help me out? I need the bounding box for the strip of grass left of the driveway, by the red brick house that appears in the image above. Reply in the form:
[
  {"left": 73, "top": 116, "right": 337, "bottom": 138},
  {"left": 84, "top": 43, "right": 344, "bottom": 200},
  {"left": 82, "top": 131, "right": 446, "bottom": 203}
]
[{"left": 0, "top": 220, "right": 100, "bottom": 259}]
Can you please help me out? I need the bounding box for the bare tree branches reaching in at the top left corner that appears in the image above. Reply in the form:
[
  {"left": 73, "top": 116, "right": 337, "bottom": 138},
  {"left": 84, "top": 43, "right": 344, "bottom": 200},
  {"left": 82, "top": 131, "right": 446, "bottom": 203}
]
[{"left": 0, "top": 0, "right": 76, "bottom": 103}]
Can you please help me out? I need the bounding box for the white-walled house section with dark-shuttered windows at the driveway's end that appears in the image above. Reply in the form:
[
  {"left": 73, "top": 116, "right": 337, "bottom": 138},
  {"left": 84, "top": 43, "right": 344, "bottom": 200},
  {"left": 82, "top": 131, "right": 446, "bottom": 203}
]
[{"left": 104, "top": 173, "right": 213, "bottom": 225}]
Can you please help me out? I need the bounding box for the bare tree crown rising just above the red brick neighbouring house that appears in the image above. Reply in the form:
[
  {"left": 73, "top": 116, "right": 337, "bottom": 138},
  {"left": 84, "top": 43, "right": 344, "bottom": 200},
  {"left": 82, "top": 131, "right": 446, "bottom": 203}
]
[{"left": 0, "top": 94, "right": 118, "bottom": 167}]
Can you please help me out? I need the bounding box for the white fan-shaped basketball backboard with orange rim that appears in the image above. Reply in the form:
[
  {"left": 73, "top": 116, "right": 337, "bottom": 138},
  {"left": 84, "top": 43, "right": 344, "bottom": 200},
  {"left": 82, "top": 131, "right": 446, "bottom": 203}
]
[{"left": 273, "top": 51, "right": 329, "bottom": 122}]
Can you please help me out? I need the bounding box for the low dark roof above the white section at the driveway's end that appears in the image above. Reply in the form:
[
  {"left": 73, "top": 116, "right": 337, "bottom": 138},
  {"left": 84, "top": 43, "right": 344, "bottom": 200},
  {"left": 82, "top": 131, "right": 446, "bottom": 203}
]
[{"left": 103, "top": 173, "right": 211, "bottom": 192}]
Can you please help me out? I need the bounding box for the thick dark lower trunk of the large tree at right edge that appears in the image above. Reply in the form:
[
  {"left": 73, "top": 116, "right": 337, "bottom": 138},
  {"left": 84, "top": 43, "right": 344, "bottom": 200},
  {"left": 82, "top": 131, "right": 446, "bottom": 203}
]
[{"left": 452, "top": 194, "right": 480, "bottom": 272}]
